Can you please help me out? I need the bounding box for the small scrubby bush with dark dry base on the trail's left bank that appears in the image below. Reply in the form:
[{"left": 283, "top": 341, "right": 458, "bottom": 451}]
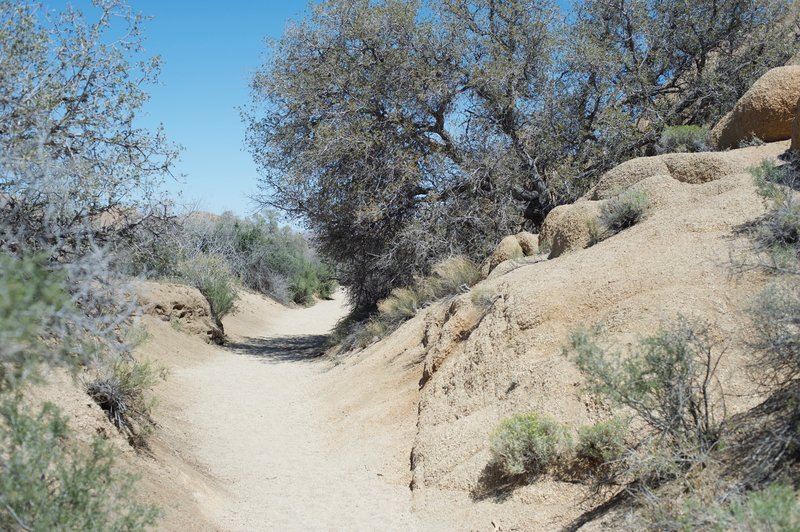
[{"left": 86, "top": 359, "right": 167, "bottom": 447}]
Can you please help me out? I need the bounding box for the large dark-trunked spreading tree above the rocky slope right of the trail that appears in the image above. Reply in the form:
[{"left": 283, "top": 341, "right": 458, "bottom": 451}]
[{"left": 245, "top": 0, "right": 794, "bottom": 309}]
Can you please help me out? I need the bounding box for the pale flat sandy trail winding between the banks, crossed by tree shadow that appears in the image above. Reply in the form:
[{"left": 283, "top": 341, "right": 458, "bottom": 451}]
[{"left": 174, "top": 297, "right": 438, "bottom": 530}]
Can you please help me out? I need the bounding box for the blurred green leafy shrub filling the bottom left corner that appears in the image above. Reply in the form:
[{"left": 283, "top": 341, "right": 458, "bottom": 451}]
[{"left": 0, "top": 399, "right": 159, "bottom": 531}]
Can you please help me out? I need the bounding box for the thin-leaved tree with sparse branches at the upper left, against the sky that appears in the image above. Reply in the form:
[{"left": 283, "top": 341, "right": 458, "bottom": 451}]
[{"left": 0, "top": 0, "right": 177, "bottom": 258}]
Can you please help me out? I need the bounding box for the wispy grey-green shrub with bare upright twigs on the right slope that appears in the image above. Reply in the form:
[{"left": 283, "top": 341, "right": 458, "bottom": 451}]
[{"left": 566, "top": 318, "right": 725, "bottom": 470}]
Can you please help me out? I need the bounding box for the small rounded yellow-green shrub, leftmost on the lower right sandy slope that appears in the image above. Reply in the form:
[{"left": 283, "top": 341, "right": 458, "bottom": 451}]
[{"left": 490, "top": 413, "right": 572, "bottom": 477}]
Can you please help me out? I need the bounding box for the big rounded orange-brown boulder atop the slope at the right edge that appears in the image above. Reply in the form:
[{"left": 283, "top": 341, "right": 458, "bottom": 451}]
[{"left": 711, "top": 65, "right": 800, "bottom": 150}]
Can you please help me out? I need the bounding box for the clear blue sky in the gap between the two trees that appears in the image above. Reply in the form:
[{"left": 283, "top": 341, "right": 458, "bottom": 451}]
[{"left": 56, "top": 0, "right": 568, "bottom": 215}]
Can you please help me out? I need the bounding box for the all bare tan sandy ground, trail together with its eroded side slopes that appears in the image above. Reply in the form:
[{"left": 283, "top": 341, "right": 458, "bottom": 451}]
[{"left": 26, "top": 142, "right": 787, "bottom": 530}]
